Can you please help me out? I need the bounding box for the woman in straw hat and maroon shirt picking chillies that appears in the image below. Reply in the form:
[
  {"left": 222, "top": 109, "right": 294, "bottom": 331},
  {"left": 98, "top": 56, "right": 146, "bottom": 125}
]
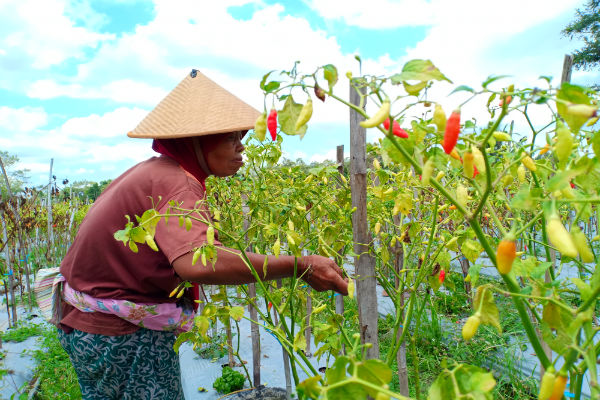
[{"left": 57, "top": 70, "right": 348, "bottom": 400}]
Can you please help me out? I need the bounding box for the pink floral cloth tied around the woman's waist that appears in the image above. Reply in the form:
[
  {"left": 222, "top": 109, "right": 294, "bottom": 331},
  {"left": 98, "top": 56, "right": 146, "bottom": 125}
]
[{"left": 55, "top": 275, "right": 195, "bottom": 333}]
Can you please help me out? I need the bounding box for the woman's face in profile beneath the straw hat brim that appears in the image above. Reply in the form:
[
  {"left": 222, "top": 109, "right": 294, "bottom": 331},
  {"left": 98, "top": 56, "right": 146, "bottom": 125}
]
[{"left": 200, "top": 132, "right": 244, "bottom": 177}]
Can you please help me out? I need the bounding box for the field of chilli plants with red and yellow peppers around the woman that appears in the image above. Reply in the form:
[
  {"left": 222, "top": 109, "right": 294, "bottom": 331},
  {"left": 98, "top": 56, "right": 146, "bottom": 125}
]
[{"left": 0, "top": 60, "right": 600, "bottom": 400}]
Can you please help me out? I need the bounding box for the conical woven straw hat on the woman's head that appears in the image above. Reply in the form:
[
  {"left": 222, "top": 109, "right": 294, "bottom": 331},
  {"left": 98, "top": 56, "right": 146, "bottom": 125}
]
[{"left": 127, "top": 69, "right": 260, "bottom": 139}]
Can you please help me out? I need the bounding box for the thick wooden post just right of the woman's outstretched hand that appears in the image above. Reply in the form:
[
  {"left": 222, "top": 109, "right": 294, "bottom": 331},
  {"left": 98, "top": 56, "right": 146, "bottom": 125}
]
[{"left": 350, "top": 81, "right": 379, "bottom": 358}]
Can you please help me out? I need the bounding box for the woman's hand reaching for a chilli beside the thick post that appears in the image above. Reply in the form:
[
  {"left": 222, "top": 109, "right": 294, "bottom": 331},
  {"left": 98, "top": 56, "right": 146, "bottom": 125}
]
[{"left": 299, "top": 255, "right": 348, "bottom": 296}]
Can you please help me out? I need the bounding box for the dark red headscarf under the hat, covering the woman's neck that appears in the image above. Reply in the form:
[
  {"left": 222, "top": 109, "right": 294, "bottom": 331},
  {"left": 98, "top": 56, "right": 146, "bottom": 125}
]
[{"left": 152, "top": 138, "right": 208, "bottom": 190}]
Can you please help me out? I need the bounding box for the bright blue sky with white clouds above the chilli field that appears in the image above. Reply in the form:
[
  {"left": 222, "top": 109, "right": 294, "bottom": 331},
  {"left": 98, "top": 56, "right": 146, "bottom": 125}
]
[{"left": 0, "top": 0, "right": 600, "bottom": 186}]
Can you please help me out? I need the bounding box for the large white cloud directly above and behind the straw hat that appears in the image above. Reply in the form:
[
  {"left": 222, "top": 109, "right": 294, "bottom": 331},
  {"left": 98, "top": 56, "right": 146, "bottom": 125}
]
[{"left": 28, "top": 0, "right": 351, "bottom": 108}]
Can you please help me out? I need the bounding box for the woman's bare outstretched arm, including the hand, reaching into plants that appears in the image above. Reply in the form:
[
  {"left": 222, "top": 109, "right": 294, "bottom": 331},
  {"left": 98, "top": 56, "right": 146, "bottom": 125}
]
[{"left": 173, "top": 246, "right": 348, "bottom": 295}]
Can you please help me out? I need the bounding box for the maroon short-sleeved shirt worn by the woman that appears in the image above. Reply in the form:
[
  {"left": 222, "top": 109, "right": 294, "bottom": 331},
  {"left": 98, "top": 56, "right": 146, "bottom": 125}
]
[{"left": 60, "top": 156, "right": 219, "bottom": 336}]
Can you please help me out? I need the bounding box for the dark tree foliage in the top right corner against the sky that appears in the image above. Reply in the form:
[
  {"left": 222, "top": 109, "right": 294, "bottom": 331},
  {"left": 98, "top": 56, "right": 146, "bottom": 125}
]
[{"left": 562, "top": 0, "right": 600, "bottom": 70}]
